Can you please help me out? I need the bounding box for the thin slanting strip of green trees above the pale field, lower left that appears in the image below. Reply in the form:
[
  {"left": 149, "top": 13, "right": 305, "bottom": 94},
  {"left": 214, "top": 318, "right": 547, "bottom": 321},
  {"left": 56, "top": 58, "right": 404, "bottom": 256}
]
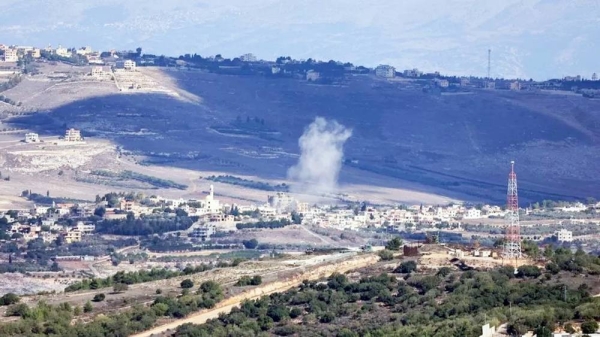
[{"left": 65, "top": 262, "right": 213, "bottom": 292}]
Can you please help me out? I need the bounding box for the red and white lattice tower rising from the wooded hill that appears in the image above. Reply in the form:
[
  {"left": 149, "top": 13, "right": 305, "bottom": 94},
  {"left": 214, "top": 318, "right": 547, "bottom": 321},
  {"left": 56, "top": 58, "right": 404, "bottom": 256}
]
[{"left": 503, "top": 161, "right": 521, "bottom": 259}]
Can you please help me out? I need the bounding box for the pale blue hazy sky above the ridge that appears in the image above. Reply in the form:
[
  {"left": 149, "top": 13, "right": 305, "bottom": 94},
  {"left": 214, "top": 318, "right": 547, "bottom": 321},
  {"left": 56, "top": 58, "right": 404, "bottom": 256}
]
[{"left": 0, "top": 0, "right": 600, "bottom": 80}]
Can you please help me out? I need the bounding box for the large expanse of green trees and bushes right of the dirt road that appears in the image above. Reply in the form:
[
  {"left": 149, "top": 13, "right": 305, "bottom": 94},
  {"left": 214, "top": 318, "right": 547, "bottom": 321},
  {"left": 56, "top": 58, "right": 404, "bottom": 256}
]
[{"left": 175, "top": 252, "right": 600, "bottom": 337}]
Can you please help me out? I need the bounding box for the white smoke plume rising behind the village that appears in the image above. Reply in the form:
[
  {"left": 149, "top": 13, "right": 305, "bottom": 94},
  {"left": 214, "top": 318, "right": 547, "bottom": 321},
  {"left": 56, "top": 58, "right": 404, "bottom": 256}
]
[{"left": 288, "top": 117, "right": 352, "bottom": 194}]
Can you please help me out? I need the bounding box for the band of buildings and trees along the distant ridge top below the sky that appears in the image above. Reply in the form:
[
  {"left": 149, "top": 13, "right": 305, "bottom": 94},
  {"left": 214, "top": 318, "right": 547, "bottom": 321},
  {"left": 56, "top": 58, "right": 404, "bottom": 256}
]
[{"left": 0, "top": 44, "right": 600, "bottom": 98}]
